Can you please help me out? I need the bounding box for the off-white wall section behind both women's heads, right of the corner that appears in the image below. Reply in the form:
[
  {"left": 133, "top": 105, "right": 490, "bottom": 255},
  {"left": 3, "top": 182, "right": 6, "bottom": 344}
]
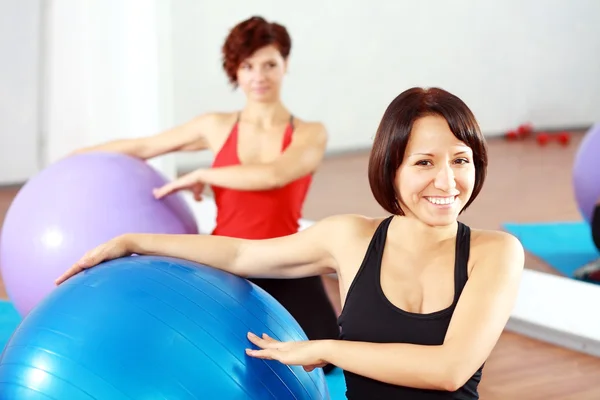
[{"left": 172, "top": 0, "right": 600, "bottom": 167}]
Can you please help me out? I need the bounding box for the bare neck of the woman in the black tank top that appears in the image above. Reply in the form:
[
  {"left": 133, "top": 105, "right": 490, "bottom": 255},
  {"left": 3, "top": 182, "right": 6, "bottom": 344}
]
[{"left": 390, "top": 216, "right": 458, "bottom": 251}]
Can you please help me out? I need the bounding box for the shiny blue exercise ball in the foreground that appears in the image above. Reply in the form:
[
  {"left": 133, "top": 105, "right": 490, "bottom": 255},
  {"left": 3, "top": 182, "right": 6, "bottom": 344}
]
[{"left": 0, "top": 256, "right": 329, "bottom": 400}]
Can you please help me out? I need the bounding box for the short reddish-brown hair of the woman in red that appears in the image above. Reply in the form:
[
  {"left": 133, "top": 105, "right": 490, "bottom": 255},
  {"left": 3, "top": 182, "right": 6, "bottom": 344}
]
[{"left": 221, "top": 16, "right": 292, "bottom": 87}]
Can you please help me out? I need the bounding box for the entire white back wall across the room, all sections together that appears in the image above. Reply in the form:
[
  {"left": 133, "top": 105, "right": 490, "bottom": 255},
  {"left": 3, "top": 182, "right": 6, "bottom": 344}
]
[{"left": 11, "top": 0, "right": 600, "bottom": 178}]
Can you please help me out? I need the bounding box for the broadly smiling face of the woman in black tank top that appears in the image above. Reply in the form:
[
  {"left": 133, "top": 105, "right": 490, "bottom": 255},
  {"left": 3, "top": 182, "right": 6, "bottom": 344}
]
[{"left": 394, "top": 115, "right": 475, "bottom": 226}]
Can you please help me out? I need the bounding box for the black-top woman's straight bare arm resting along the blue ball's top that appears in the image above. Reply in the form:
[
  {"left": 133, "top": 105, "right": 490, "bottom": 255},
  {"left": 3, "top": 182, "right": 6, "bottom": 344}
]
[{"left": 56, "top": 216, "right": 356, "bottom": 284}]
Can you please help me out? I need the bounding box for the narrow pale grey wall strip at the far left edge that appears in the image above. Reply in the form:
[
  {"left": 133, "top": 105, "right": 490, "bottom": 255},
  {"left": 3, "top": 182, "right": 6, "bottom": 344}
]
[{"left": 0, "top": 0, "right": 41, "bottom": 185}]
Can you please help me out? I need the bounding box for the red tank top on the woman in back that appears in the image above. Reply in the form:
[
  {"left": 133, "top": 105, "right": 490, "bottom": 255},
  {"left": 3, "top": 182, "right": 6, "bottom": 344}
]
[{"left": 212, "top": 117, "right": 312, "bottom": 239}]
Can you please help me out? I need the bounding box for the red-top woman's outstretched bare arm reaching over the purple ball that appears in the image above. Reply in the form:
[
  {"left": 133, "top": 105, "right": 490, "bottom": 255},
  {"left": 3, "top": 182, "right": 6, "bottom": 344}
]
[{"left": 73, "top": 114, "right": 215, "bottom": 160}]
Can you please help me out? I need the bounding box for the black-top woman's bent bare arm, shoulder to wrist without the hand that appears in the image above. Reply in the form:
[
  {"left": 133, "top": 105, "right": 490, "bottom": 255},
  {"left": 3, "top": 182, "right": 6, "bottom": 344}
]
[{"left": 323, "top": 234, "right": 524, "bottom": 391}]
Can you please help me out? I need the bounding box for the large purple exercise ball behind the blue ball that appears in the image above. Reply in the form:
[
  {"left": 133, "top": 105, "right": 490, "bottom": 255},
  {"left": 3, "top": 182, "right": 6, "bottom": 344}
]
[{"left": 0, "top": 152, "right": 198, "bottom": 316}]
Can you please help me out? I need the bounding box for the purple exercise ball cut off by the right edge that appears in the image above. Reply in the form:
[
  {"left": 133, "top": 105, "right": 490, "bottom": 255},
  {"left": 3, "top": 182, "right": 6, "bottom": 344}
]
[{"left": 573, "top": 123, "right": 600, "bottom": 222}]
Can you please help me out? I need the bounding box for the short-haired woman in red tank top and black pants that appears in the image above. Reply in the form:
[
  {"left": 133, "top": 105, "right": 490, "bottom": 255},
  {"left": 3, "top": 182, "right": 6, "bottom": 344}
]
[{"left": 69, "top": 17, "right": 340, "bottom": 372}]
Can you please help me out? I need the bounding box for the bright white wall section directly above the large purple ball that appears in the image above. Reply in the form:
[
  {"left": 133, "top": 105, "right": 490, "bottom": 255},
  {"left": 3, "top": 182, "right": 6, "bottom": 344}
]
[{"left": 43, "top": 0, "right": 174, "bottom": 175}]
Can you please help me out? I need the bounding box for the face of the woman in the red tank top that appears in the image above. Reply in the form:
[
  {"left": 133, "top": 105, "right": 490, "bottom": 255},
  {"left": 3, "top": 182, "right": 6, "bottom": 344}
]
[{"left": 237, "top": 45, "right": 287, "bottom": 102}]
